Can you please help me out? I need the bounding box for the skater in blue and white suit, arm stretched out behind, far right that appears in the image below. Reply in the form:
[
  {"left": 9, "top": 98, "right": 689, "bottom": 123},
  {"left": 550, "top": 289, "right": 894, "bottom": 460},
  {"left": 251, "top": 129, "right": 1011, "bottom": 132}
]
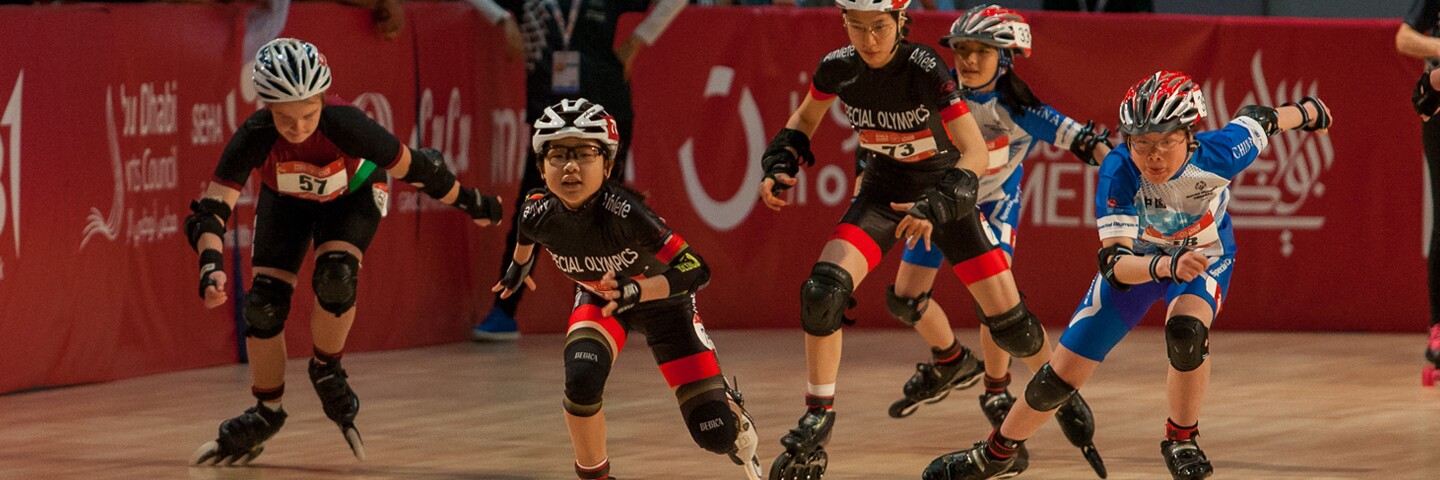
[{"left": 924, "top": 71, "right": 1331, "bottom": 480}]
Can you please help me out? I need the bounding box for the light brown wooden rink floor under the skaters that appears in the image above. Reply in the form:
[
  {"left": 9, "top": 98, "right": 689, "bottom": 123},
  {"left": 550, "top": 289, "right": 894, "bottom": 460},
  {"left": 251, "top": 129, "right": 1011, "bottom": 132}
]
[{"left": 0, "top": 329, "right": 1440, "bottom": 480}]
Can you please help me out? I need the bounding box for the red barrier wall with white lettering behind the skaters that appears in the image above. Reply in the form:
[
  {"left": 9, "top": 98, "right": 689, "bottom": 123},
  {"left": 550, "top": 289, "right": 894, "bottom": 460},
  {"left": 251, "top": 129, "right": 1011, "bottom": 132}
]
[{"left": 0, "top": 3, "right": 1426, "bottom": 392}]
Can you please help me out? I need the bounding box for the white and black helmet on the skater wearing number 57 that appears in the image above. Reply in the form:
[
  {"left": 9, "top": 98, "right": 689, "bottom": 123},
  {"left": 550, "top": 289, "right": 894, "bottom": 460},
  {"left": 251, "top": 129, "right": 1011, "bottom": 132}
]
[{"left": 251, "top": 39, "right": 330, "bottom": 104}]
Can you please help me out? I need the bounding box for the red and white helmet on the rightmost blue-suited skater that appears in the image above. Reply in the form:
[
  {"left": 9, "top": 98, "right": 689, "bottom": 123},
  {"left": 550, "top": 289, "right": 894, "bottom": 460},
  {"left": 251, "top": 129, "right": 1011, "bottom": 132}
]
[{"left": 1120, "top": 71, "right": 1205, "bottom": 135}]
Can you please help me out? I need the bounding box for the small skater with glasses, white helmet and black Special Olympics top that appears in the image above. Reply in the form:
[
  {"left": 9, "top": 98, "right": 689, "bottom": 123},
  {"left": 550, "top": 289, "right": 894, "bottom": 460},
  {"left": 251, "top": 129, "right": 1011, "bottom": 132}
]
[{"left": 491, "top": 98, "right": 763, "bottom": 480}]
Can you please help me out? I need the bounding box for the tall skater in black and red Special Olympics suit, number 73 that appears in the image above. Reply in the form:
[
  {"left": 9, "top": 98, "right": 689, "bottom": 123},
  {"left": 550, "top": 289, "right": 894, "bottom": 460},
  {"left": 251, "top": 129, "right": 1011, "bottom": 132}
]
[{"left": 759, "top": 0, "right": 1071, "bottom": 479}]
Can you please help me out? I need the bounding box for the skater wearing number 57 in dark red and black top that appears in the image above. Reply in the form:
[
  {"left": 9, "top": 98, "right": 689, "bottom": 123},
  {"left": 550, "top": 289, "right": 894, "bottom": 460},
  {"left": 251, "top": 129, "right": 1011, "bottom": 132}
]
[{"left": 184, "top": 39, "right": 501, "bottom": 464}]
